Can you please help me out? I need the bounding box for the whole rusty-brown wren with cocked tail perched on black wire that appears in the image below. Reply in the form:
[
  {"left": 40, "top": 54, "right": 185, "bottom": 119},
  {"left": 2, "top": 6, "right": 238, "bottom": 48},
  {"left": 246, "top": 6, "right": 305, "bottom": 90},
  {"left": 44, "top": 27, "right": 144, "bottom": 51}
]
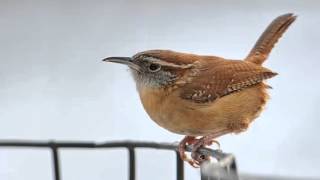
[{"left": 104, "top": 14, "right": 296, "bottom": 166}]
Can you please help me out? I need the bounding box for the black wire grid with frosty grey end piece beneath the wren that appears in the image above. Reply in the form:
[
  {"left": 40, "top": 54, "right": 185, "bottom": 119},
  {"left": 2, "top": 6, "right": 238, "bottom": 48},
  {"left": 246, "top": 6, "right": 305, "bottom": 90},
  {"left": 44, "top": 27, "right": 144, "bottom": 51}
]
[{"left": 0, "top": 141, "right": 239, "bottom": 180}]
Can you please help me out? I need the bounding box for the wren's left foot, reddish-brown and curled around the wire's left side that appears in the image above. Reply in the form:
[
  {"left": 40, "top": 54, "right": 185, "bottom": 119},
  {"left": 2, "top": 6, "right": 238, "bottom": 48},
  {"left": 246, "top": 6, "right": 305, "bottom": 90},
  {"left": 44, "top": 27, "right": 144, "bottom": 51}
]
[{"left": 178, "top": 136, "right": 198, "bottom": 167}]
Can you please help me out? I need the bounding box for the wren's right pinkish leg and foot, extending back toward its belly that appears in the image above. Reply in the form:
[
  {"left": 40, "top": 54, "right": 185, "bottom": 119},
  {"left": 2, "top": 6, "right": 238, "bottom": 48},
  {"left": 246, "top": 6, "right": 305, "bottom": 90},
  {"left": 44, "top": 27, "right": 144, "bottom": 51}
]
[{"left": 191, "top": 130, "right": 230, "bottom": 165}]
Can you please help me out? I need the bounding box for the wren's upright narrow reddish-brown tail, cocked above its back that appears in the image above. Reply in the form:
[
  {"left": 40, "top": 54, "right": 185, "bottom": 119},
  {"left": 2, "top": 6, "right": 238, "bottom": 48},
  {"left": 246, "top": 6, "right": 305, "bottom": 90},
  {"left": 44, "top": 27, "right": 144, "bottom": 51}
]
[{"left": 245, "top": 13, "right": 297, "bottom": 65}]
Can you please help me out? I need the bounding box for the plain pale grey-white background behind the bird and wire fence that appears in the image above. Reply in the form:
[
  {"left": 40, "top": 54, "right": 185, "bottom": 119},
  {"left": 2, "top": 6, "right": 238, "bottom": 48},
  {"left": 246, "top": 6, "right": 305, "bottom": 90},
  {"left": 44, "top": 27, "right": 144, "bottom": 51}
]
[{"left": 0, "top": 0, "right": 320, "bottom": 180}]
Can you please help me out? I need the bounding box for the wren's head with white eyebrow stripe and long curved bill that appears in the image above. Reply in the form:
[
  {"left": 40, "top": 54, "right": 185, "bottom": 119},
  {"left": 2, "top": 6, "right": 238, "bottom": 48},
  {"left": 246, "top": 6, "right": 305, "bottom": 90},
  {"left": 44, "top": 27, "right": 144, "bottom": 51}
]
[{"left": 103, "top": 50, "right": 197, "bottom": 88}]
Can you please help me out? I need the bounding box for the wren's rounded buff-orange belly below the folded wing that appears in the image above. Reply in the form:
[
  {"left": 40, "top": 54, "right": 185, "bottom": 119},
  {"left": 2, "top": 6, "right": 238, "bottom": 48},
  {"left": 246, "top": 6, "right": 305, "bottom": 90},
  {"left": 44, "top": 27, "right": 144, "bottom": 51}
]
[{"left": 140, "top": 84, "right": 268, "bottom": 136}]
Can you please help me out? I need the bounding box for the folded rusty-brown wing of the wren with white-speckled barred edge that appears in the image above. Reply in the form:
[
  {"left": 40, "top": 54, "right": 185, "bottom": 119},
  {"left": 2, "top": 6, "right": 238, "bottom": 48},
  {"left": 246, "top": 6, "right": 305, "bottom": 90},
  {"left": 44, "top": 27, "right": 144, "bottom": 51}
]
[{"left": 180, "top": 61, "right": 277, "bottom": 103}]
